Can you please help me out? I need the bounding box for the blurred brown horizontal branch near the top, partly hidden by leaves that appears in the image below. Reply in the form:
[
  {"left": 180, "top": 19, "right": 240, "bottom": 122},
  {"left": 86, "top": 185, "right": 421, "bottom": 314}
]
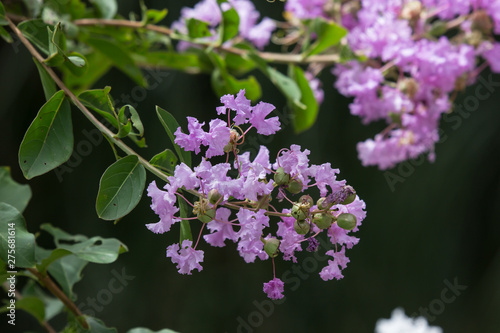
[{"left": 73, "top": 19, "right": 340, "bottom": 64}]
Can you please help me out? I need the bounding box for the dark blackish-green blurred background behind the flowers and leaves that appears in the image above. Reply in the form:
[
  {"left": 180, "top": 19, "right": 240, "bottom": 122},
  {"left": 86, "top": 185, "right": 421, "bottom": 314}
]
[{"left": 0, "top": 0, "right": 500, "bottom": 333}]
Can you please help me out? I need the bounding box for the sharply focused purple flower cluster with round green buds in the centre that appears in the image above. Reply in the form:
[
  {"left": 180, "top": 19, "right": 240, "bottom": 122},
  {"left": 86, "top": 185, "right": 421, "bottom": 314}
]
[{"left": 146, "top": 90, "right": 366, "bottom": 299}]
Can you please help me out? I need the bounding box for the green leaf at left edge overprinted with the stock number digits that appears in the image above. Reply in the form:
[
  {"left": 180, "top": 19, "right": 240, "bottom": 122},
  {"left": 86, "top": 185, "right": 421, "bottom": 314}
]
[{"left": 0, "top": 202, "right": 35, "bottom": 270}]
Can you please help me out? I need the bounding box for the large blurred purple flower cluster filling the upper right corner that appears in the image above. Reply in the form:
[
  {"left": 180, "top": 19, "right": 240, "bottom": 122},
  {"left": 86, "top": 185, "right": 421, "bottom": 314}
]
[{"left": 285, "top": 0, "right": 500, "bottom": 169}]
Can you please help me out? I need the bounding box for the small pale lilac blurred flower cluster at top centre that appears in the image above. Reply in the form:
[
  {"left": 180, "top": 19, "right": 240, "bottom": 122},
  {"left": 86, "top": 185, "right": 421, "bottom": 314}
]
[{"left": 172, "top": 0, "right": 276, "bottom": 50}]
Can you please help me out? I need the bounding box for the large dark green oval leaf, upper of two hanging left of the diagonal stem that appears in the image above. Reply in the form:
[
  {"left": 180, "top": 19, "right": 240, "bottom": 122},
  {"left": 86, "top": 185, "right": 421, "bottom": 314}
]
[{"left": 19, "top": 90, "right": 73, "bottom": 179}]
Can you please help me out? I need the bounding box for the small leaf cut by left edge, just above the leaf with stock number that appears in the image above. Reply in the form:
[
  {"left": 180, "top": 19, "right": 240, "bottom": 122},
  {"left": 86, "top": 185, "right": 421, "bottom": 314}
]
[{"left": 0, "top": 167, "right": 31, "bottom": 213}]
